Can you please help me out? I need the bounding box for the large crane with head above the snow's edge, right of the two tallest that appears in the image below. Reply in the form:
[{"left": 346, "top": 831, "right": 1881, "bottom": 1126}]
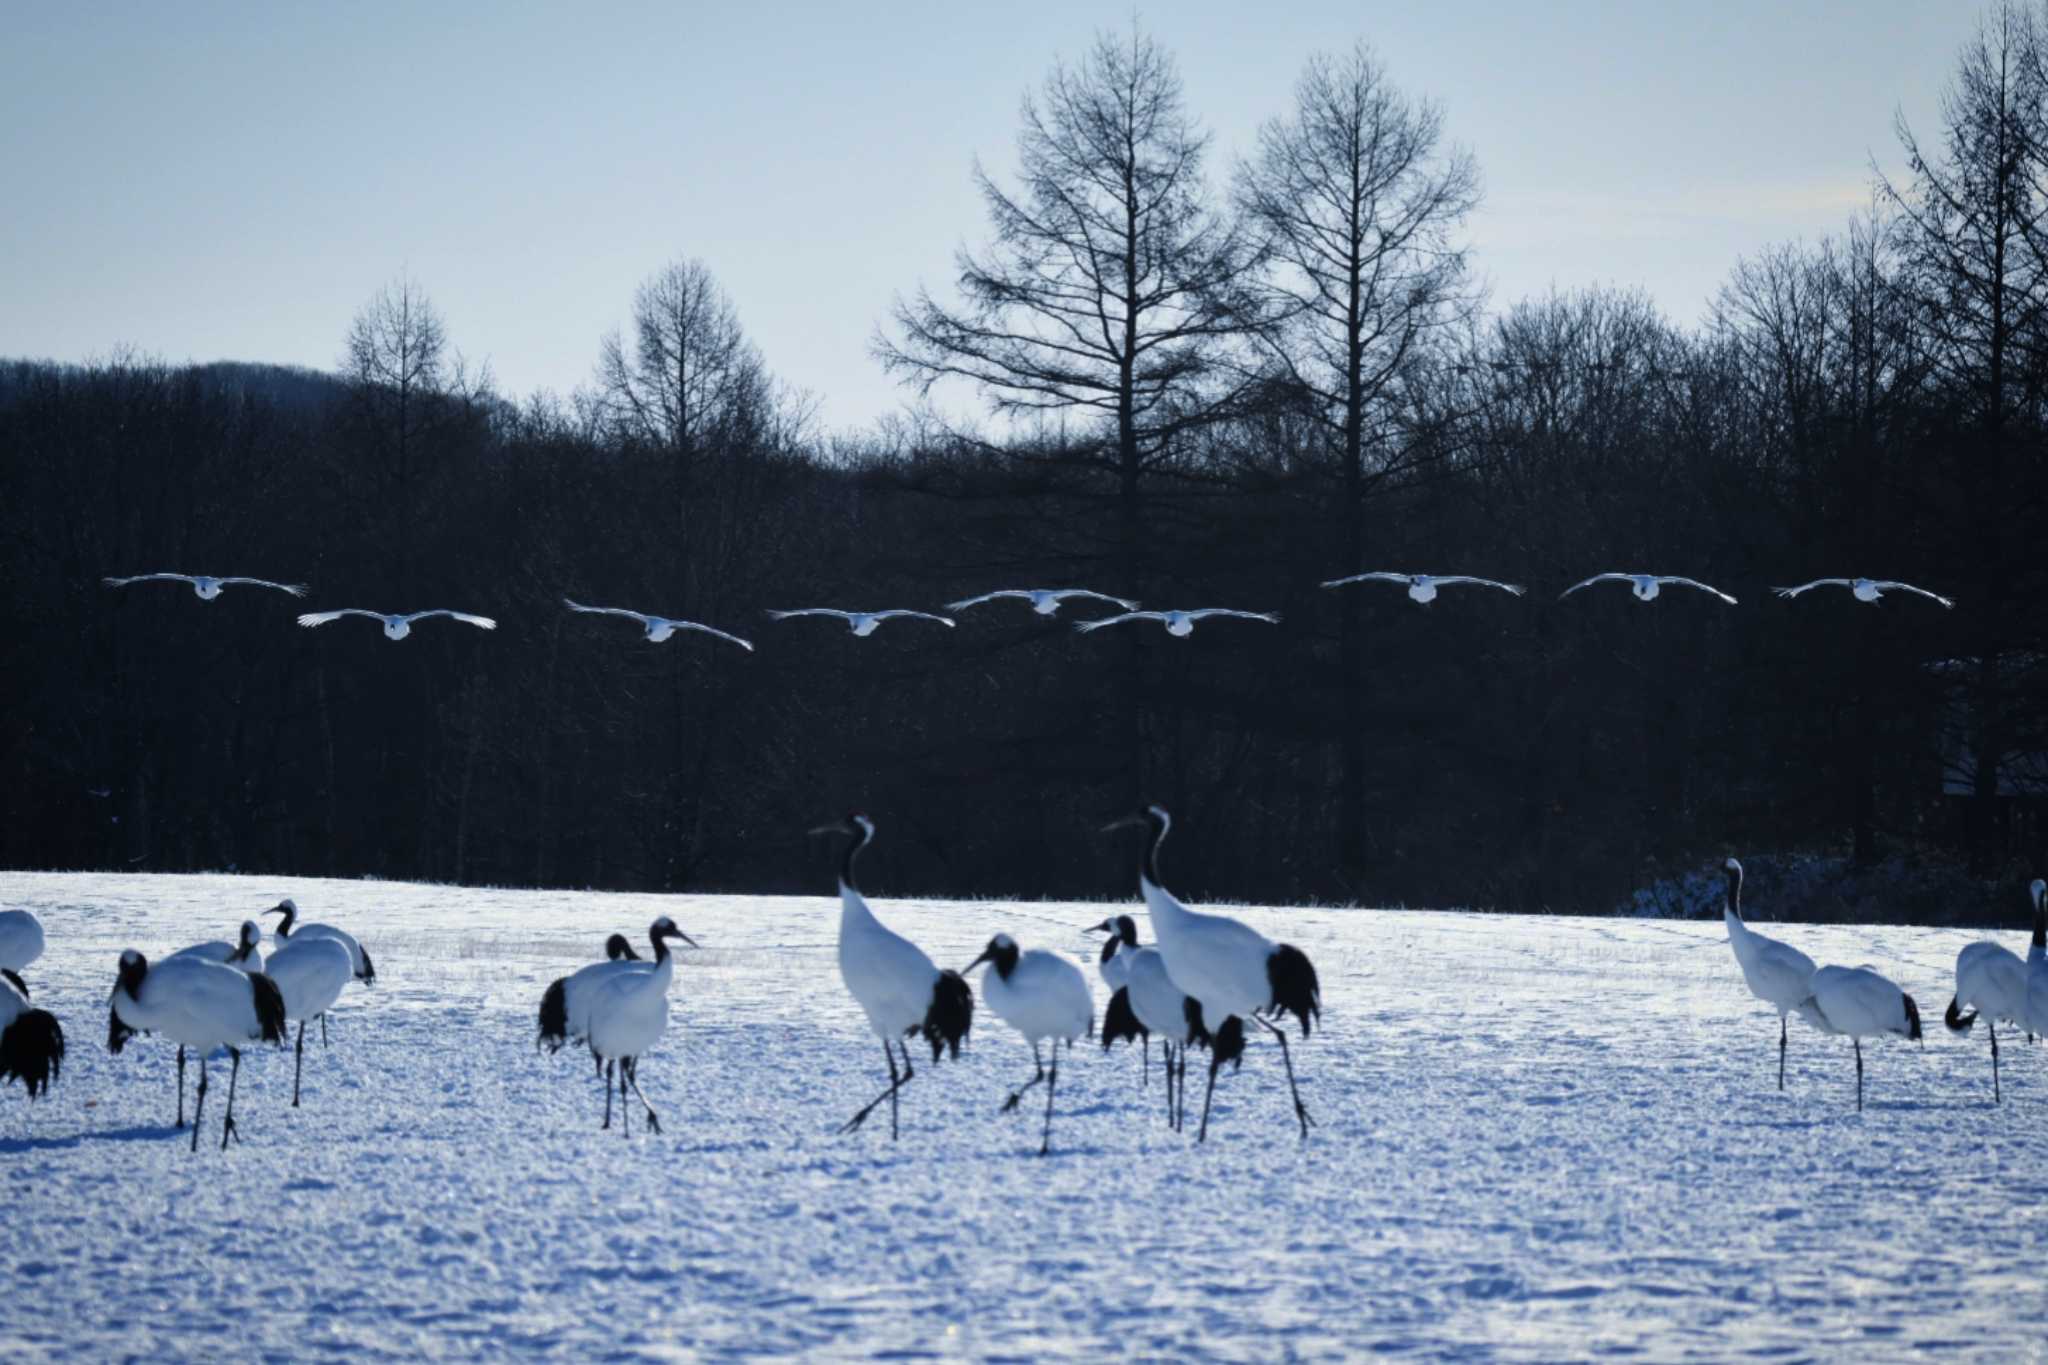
[{"left": 1110, "top": 806, "right": 1323, "bottom": 1142}]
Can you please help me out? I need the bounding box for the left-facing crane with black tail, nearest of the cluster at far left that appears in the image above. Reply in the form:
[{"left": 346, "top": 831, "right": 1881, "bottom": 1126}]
[{"left": 106, "top": 948, "right": 285, "bottom": 1152}]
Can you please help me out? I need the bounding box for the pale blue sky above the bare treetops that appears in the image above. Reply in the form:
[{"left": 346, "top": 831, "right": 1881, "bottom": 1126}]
[{"left": 0, "top": 0, "right": 1976, "bottom": 426}]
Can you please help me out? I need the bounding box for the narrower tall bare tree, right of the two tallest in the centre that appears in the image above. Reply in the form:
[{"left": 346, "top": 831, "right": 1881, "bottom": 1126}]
[{"left": 1237, "top": 43, "right": 1479, "bottom": 888}]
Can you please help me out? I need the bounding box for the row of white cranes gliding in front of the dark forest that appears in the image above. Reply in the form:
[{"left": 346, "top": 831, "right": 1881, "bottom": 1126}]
[{"left": 102, "top": 571, "right": 1956, "bottom": 653}]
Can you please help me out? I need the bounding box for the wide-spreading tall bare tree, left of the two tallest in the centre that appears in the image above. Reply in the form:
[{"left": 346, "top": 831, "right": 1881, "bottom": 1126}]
[{"left": 874, "top": 31, "right": 1249, "bottom": 577}]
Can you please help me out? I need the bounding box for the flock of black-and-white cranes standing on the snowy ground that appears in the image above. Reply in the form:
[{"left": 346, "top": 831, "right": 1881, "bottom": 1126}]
[{"left": 0, "top": 806, "right": 2048, "bottom": 1156}]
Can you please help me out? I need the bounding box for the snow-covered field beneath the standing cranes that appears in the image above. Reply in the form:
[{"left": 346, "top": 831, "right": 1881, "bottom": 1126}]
[{"left": 0, "top": 874, "right": 2048, "bottom": 1361}]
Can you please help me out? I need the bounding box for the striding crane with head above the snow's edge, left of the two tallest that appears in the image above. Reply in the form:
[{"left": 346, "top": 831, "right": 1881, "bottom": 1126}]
[{"left": 811, "top": 812, "right": 975, "bottom": 1138}]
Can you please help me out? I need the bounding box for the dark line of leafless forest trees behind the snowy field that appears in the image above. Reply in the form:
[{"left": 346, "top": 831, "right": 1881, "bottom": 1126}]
[{"left": 0, "top": 4, "right": 2048, "bottom": 911}]
